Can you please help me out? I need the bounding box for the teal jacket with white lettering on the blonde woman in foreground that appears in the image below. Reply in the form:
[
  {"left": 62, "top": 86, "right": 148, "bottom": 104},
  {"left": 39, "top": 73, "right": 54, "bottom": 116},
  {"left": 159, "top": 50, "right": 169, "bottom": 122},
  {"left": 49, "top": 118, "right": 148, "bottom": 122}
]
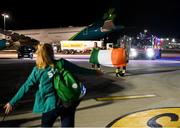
[{"left": 9, "top": 58, "right": 96, "bottom": 113}]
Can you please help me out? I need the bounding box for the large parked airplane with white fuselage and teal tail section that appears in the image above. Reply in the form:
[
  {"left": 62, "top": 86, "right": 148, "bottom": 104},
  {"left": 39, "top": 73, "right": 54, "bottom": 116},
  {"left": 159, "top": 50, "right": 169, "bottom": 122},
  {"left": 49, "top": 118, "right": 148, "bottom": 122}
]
[{"left": 2, "top": 9, "right": 124, "bottom": 42}]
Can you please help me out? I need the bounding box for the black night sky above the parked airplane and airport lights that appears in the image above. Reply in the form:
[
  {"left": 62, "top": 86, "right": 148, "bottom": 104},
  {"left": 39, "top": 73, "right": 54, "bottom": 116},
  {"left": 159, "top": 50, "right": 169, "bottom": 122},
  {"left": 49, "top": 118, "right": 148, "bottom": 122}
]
[{"left": 0, "top": 0, "right": 180, "bottom": 38}]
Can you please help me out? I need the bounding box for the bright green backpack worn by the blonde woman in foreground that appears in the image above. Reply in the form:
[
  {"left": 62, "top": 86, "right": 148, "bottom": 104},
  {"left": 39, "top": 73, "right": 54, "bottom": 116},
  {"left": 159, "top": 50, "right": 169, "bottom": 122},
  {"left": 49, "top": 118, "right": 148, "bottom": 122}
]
[{"left": 54, "top": 61, "right": 86, "bottom": 107}]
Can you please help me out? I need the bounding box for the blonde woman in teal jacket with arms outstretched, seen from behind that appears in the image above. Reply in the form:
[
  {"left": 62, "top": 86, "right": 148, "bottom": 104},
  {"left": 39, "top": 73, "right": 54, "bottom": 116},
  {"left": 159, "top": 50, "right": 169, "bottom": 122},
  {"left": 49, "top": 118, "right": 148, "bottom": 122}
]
[{"left": 4, "top": 43, "right": 100, "bottom": 127}]
